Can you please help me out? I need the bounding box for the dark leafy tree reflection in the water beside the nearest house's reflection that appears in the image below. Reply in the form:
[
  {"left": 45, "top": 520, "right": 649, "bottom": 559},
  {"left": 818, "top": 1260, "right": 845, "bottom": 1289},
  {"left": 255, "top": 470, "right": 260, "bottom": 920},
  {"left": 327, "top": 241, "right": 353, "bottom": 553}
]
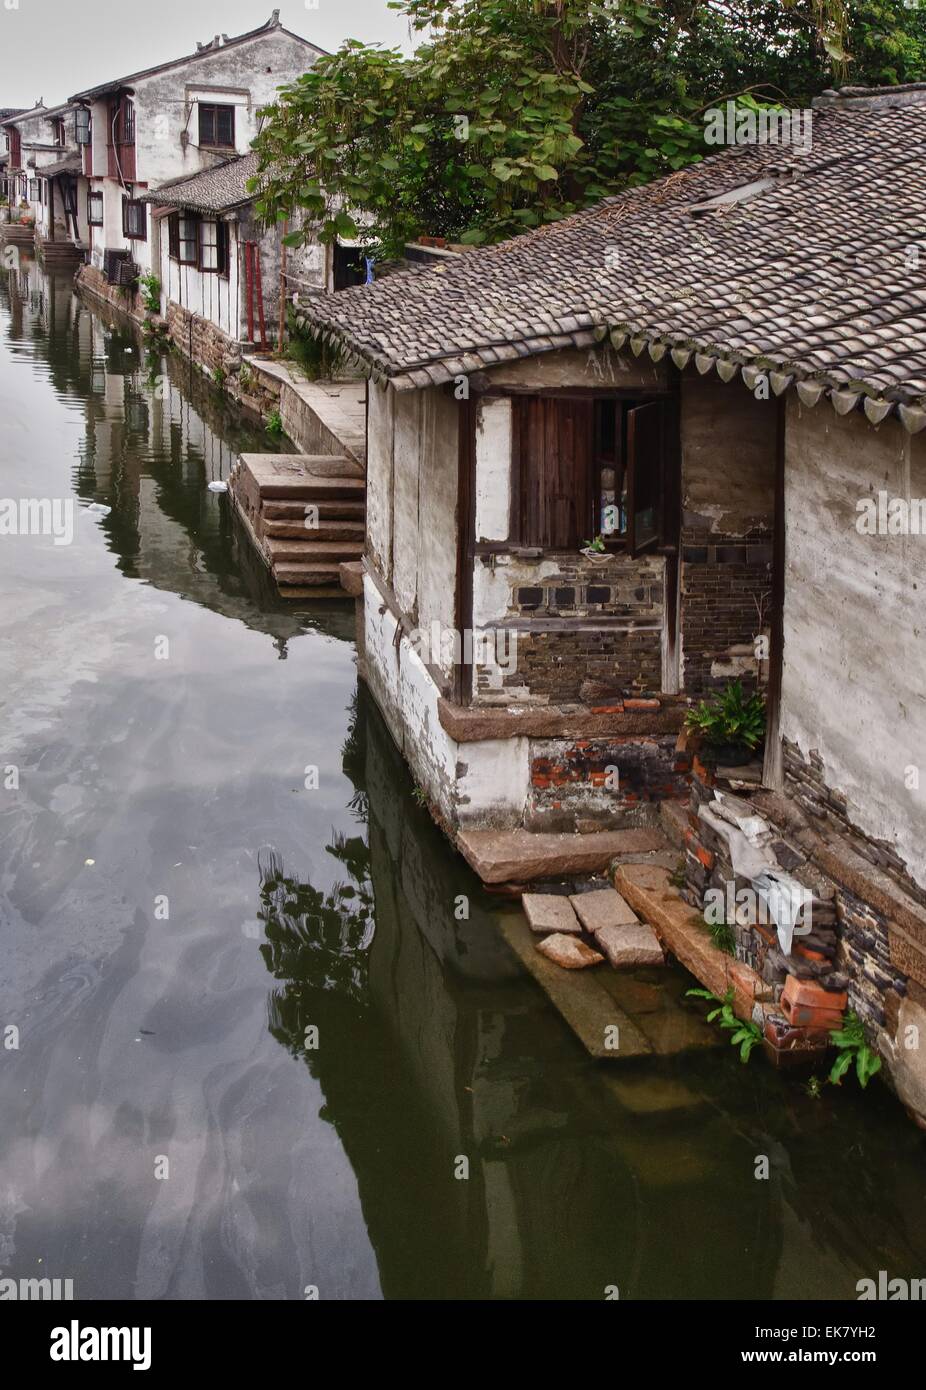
[{"left": 257, "top": 696, "right": 375, "bottom": 1054}]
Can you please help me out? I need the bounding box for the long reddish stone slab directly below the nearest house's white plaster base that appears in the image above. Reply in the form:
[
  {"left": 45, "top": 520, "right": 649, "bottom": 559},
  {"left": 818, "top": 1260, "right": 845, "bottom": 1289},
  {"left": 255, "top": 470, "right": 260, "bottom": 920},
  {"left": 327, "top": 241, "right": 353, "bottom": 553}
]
[{"left": 456, "top": 828, "right": 667, "bottom": 883}]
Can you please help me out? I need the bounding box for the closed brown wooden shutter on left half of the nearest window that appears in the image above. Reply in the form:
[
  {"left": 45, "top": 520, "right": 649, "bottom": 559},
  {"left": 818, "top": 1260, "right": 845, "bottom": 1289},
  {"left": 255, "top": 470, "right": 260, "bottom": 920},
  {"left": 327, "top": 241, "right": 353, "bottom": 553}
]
[{"left": 514, "top": 396, "right": 595, "bottom": 550}]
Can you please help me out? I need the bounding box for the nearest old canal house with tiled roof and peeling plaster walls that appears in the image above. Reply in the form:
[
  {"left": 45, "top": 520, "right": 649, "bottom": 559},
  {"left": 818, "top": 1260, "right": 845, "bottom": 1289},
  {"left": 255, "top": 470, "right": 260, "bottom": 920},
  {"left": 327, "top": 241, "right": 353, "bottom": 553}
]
[{"left": 309, "top": 85, "right": 926, "bottom": 1118}]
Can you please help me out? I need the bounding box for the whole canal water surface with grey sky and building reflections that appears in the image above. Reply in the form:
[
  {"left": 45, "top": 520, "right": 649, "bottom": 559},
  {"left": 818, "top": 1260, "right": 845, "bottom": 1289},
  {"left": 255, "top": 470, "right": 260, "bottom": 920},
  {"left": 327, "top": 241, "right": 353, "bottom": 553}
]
[{"left": 0, "top": 259, "right": 926, "bottom": 1300}]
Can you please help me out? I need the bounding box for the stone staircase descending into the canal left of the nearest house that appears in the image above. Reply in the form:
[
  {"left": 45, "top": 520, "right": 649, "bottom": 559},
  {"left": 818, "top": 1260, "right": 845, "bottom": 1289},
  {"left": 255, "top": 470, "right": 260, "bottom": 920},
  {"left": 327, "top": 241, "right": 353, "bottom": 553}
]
[{"left": 228, "top": 453, "right": 366, "bottom": 599}]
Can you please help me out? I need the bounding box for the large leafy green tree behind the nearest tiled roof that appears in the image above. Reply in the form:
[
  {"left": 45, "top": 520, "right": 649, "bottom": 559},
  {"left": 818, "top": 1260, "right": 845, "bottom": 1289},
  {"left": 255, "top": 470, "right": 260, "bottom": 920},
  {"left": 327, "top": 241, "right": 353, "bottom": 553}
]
[{"left": 253, "top": 0, "right": 926, "bottom": 256}]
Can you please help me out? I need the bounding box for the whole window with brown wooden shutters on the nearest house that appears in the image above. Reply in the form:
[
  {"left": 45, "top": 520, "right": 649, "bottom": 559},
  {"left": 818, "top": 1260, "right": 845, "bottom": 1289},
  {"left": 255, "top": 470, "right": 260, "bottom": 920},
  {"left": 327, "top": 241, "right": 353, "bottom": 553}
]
[{"left": 513, "top": 396, "right": 665, "bottom": 555}]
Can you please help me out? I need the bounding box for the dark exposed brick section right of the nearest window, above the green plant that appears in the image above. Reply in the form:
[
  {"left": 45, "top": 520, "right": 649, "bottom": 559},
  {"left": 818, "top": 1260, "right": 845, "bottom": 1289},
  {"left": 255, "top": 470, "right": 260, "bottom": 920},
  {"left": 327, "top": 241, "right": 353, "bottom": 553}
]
[{"left": 680, "top": 527, "right": 772, "bottom": 694}]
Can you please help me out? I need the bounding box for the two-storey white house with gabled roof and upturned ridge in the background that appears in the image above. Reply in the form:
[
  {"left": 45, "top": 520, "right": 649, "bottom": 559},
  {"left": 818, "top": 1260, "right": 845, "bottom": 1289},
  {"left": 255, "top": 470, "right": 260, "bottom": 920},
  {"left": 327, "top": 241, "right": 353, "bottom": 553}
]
[{"left": 71, "top": 10, "right": 323, "bottom": 309}]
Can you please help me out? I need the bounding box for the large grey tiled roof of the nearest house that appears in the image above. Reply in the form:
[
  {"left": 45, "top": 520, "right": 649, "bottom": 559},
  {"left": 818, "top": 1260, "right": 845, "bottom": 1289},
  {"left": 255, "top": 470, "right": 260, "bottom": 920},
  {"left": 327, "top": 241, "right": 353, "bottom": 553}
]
[{"left": 303, "top": 88, "right": 926, "bottom": 428}]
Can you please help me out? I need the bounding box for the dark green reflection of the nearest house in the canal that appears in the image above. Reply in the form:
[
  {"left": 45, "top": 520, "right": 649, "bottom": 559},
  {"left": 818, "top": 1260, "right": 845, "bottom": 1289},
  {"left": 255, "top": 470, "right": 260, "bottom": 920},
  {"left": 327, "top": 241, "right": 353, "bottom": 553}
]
[{"left": 254, "top": 683, "right": 926, "bottom": 1298}]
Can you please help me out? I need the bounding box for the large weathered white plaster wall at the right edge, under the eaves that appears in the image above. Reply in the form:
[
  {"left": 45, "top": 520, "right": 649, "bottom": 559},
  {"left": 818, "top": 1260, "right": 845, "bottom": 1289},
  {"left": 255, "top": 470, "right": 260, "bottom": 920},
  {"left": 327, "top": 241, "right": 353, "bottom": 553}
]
[{"left": 781, "top": 398, "right": 926, "bottom": 885}]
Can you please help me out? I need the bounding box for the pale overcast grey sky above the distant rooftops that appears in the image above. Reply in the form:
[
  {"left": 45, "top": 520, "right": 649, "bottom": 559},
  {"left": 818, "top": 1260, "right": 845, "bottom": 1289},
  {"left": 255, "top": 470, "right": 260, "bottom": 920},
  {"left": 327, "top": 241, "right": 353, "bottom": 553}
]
[{"left": 0, "top": 0, "right": 409, "bottom": 107}]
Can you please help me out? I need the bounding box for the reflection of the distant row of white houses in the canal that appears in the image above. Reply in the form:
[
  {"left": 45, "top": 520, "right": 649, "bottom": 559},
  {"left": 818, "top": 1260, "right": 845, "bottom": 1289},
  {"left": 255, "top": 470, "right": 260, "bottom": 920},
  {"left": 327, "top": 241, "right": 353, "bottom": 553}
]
[{"left": 0, "top": 253, "right": 353, "bottom": 644}]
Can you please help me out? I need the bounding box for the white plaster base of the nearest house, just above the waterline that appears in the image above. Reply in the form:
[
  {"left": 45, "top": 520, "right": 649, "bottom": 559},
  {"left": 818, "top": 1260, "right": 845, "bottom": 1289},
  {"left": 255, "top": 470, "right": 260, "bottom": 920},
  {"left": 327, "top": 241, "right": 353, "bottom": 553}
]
[{"left": 364, "top": 575, "right": 530, "bottom": 826}]
